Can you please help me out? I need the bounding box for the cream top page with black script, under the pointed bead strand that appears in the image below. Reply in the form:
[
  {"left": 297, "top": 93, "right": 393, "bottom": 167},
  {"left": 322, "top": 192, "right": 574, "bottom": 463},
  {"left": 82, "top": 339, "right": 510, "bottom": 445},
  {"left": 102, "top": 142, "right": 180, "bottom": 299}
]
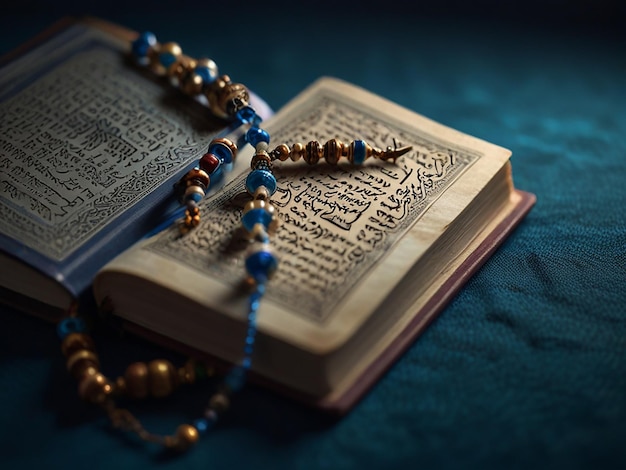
[{"left": 102, "top": 75, "right": 510, "bottom": 348}]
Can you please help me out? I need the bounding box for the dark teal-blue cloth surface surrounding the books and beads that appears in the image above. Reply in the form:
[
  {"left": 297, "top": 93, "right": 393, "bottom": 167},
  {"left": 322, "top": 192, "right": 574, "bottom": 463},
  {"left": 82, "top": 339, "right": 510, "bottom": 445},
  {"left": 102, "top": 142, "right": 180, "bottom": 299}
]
[{"left": 0, "top": 0, "right": 626, "bottom": 469}]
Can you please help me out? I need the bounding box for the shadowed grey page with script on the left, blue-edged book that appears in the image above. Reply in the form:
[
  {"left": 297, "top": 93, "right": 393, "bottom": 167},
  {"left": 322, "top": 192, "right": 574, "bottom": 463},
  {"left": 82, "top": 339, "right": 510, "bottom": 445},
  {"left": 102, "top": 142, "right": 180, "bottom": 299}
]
[{"left": 0, "top": 24, "right": 224, "bottom": 261}]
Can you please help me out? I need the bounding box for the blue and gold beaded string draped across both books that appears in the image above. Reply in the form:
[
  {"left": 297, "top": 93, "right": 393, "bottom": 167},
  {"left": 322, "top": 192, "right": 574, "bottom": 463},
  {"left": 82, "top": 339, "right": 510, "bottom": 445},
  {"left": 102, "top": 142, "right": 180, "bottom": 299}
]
[{"left": 57, "top": 33, "right": 411, "bottom": 451}]
